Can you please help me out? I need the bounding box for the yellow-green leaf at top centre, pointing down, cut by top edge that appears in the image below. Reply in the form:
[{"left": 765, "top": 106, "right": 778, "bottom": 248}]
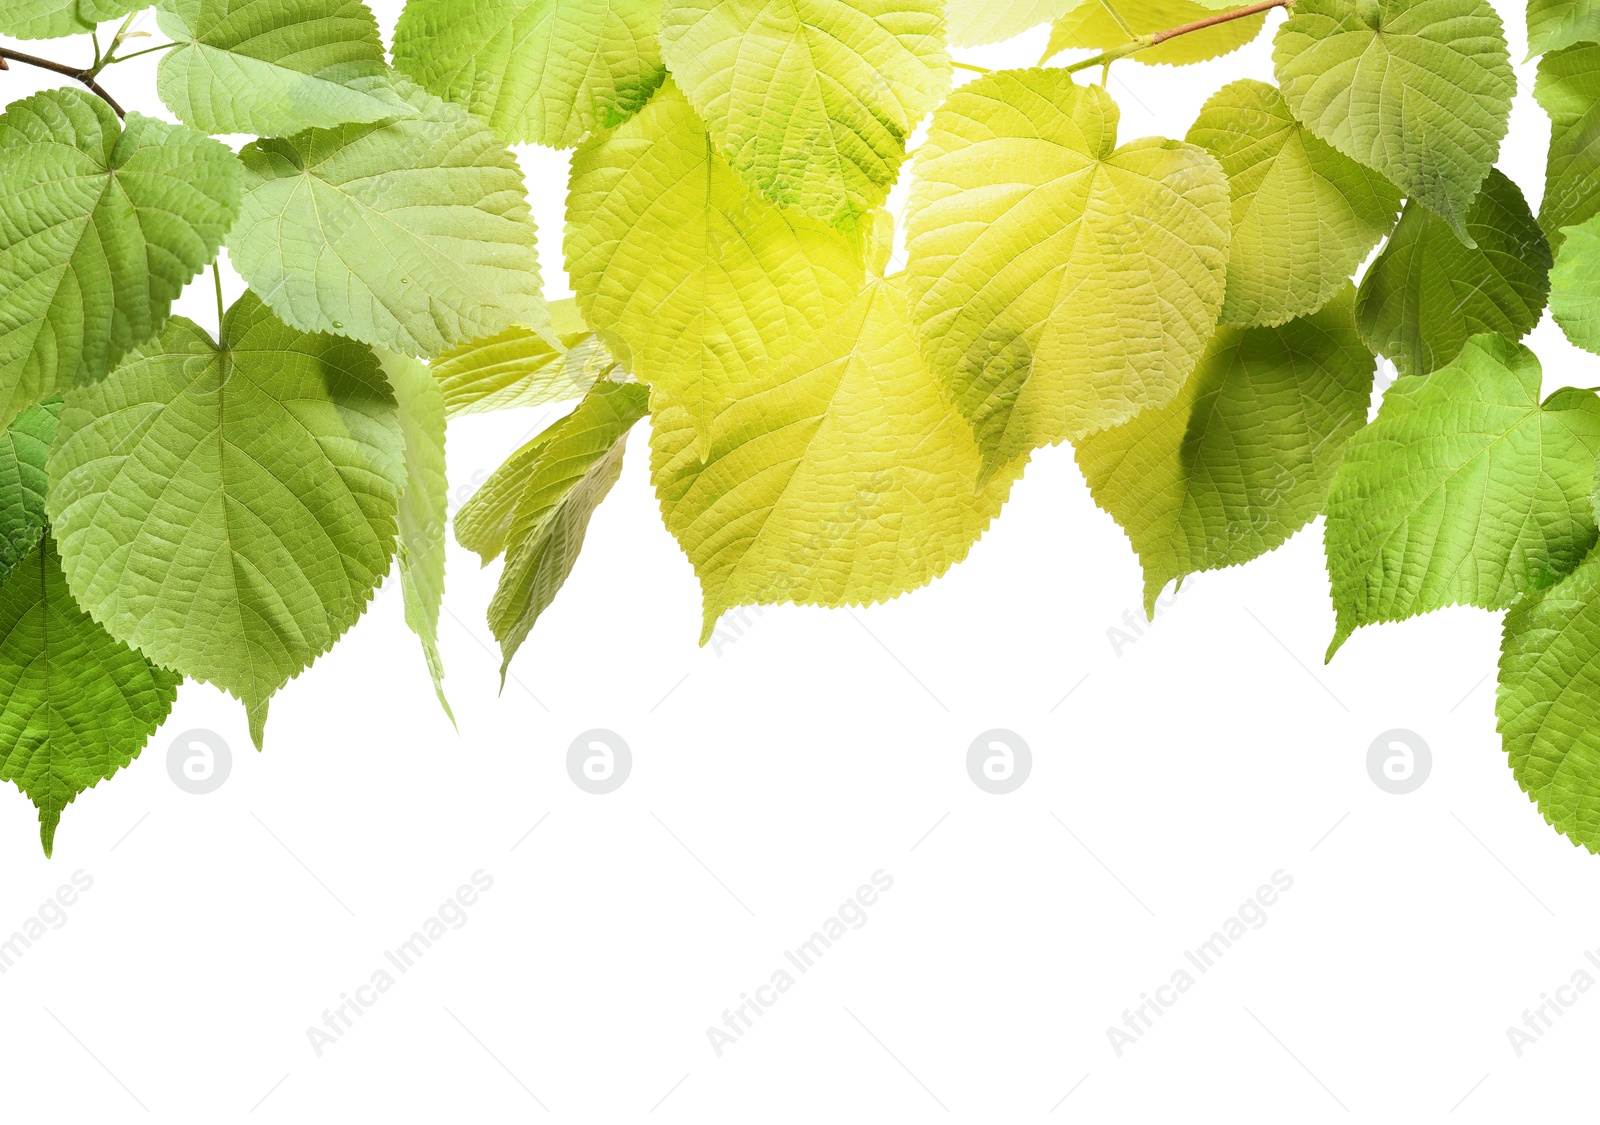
[{"left": 661, "top": 0, "right": 950, "bottom": 227}]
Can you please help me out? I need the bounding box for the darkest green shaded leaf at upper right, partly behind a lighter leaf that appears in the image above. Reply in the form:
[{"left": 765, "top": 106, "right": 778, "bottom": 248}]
[{"left": 1355, "top": 170, "right": 1550, "bottom": 374}]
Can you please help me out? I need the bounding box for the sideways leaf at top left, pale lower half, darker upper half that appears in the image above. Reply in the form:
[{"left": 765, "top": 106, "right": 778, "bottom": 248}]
[{"left": 157, "top": 0, "right": 418, "bottom": 136}]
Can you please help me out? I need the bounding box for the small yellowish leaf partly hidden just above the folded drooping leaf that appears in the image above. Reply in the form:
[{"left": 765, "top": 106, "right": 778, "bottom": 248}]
[{"left": 432, "top": 299, "right": 616, "bottom": 418}]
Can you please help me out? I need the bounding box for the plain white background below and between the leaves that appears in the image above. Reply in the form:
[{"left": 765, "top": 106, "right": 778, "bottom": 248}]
[{"left": 0, "top": 3, "right": 1600, "bottom": 1123}]
